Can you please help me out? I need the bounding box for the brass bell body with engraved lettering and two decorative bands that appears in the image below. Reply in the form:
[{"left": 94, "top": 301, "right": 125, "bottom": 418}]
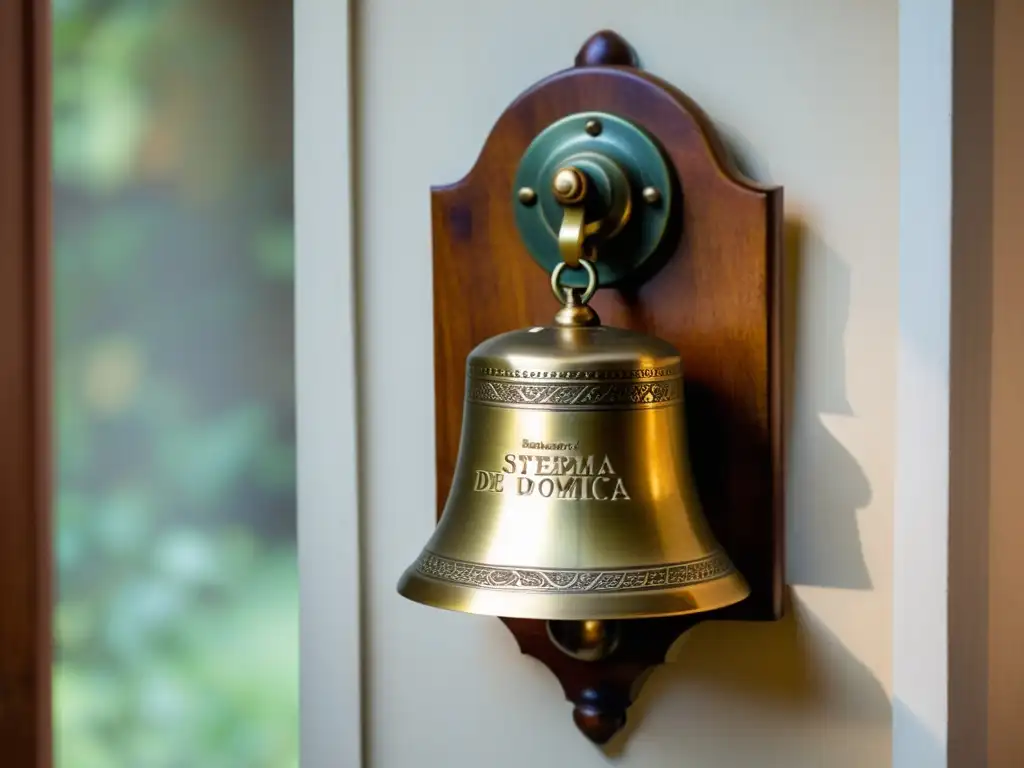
[{"left": 398, "top": 327, "right": 750, "bottom": 620}]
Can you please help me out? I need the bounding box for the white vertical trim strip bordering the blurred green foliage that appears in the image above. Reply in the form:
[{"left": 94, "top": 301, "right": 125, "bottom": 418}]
[{"left": 294, "top": 0, "right": 362, "bottom": 768}]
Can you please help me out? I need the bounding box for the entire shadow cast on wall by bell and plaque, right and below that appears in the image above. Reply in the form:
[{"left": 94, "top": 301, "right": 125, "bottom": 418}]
[{"left": 577, "top": 127, "right": 888, "bottom": 768}]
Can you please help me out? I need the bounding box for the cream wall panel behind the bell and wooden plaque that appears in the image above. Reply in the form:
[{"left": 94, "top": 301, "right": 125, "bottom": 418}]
[{"left": 352, "top": 0, "right": 899, "bottom": 768}]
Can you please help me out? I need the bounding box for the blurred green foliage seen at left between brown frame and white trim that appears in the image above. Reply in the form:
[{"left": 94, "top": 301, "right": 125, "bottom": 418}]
[{"left": 53, "top": 0, "right": 298, "bottom": 768}]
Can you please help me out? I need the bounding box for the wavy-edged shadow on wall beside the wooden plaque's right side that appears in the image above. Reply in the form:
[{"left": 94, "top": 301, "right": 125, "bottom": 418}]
[{"left": 718, "top": 124, "right": 871, "bottom": 590}]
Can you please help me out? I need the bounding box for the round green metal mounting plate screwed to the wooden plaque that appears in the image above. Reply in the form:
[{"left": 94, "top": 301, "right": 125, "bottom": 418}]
[{"left": 509, "top": 112, "right": 673, "bottom": 288}]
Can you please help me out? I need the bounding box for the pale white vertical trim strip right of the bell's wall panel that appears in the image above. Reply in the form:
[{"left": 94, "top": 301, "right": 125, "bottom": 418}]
[{"left": 893, "top": 0, "right": 953, "bottom": 768}]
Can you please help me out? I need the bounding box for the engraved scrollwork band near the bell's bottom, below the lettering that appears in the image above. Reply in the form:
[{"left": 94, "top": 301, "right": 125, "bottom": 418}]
[{"left": 416, "top": 552, "right": 733, "bottom": 594}]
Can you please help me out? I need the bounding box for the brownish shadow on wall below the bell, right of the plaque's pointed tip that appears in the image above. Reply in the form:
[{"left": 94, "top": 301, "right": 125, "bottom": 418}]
[{"left": 605, "top": 600, "right": 892, "bottom": 768}]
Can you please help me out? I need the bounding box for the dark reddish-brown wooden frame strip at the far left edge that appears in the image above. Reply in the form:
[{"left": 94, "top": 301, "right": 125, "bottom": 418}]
[{"left": 0, "top": 0, "right": 53, "bottom": 768}]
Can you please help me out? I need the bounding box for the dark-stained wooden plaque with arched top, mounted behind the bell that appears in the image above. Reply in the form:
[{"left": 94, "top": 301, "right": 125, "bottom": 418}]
[{"left": 432, "top": 32, "right": 783, "bottom": 743}]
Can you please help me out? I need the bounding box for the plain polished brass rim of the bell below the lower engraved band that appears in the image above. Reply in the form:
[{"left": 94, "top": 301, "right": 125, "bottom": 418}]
[{"left": 397, "top": 564, "right": 751, "bottom": 621}]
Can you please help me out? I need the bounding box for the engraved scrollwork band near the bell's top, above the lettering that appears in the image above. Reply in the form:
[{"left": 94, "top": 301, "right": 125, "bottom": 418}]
[{"left": 466, "top": 378, "right": 683, "bottom": 409}]
